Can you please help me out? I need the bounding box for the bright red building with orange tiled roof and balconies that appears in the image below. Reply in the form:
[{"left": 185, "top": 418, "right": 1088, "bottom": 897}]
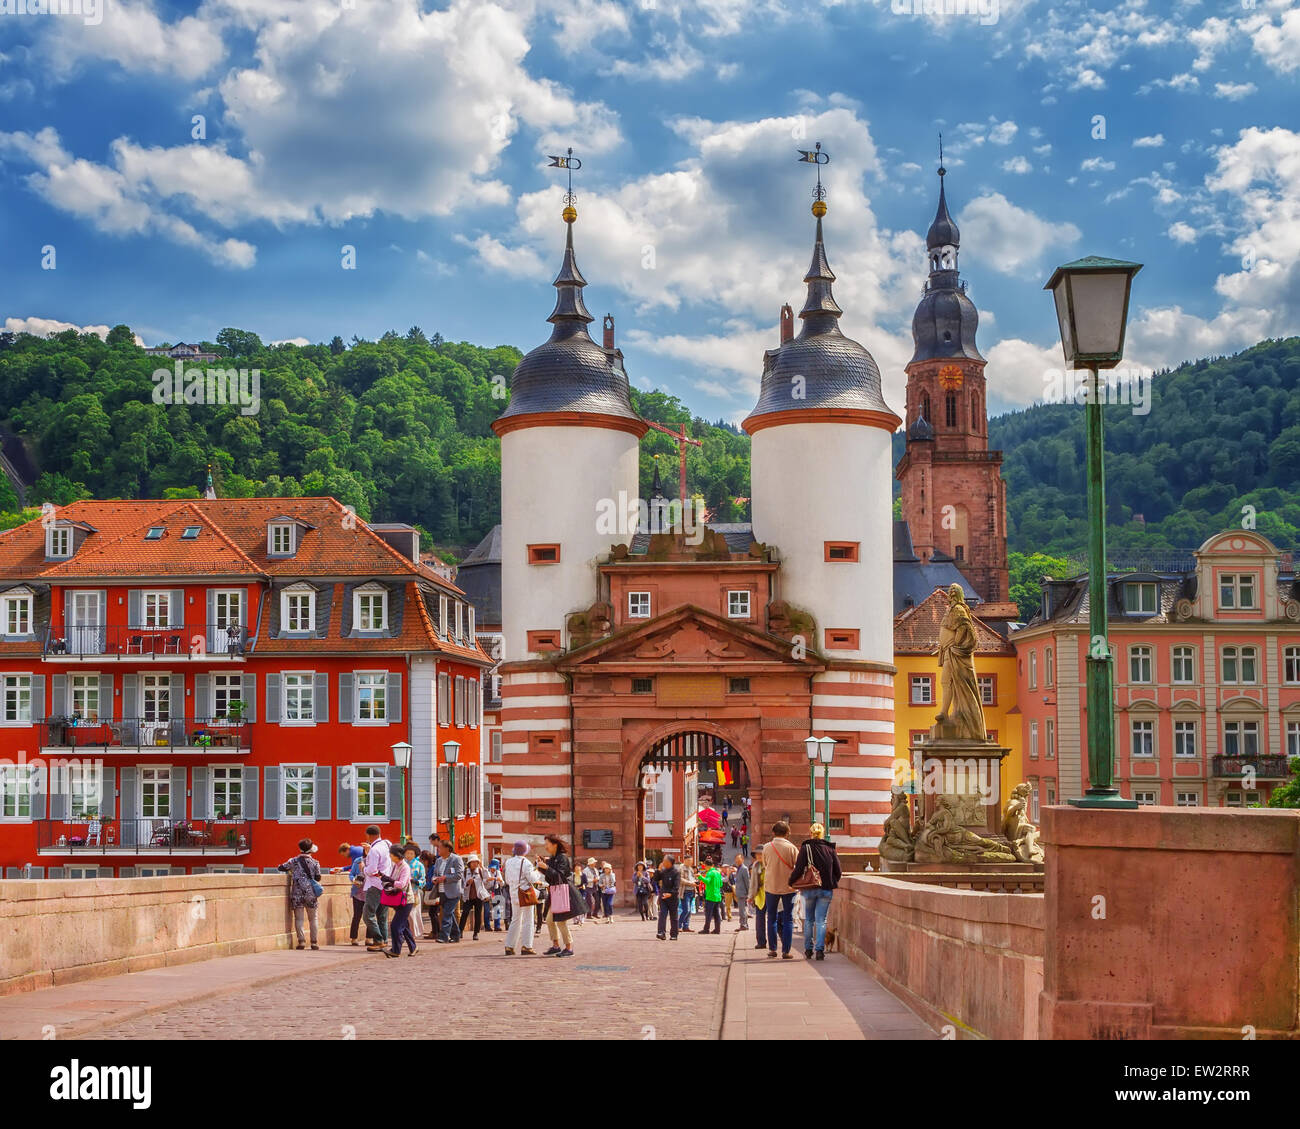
[{"left": 0, "top": 498, "right": 489, "bottom": 878}]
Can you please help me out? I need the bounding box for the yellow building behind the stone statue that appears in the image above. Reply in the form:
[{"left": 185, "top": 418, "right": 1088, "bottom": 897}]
[{"left": 894, "top": 588, "right": 1024, "bottom": 808}]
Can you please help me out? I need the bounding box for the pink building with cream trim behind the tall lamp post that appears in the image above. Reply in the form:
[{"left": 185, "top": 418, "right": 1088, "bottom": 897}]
[{"left": 1014, "top": 531, "right": 1300, "bottom": 818}]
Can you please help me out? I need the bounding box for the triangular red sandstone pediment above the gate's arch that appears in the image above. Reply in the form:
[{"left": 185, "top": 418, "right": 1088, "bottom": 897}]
[{"left": 556, "top": 604, "right": 824, "bottom": 671}]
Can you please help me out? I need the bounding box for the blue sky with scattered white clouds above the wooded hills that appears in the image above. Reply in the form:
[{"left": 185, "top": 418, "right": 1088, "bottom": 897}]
[{"left": 0, "top": 0, "right": 1300, "bottom": 421}]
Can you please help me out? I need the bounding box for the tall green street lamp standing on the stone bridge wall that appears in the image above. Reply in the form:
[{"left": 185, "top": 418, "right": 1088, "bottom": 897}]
[{"left": 1043, "top": 255, "right": 1141, "bottom": 808}]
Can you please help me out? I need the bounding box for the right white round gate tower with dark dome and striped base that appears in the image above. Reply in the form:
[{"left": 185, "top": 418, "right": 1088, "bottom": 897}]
[{"left": 744, "top": 199, "right": 901, "bottom": 848}]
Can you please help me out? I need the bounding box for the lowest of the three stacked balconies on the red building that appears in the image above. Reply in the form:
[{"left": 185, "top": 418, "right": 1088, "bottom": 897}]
[{"left": 34, "top": 818, "right": 252, "bottom": 857}]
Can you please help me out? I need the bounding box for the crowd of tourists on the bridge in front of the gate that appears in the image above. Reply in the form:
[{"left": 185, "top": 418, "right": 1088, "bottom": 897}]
[{"left": 280, "top": 821, "right": 841, "bottom": 960}]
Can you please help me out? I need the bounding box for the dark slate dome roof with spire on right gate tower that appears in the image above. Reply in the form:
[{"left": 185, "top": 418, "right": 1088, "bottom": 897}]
[{"left": 744, "top": 217, "right": 900, "bottom": 434}]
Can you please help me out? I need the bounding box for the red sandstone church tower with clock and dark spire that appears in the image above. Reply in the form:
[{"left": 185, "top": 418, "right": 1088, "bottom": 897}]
[{"left": 897, "top": 164, "right": 1009, "bottom": 604}]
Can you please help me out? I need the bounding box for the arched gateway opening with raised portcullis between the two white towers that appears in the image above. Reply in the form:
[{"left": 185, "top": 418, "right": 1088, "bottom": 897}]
[{"left": 634, "top": 728, "right": 753, "bottom": 865}]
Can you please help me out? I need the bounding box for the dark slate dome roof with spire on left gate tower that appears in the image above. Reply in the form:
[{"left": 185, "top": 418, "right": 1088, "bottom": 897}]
[{"left": 493, "top": 222, "right": 646, "bottom": 436}]
